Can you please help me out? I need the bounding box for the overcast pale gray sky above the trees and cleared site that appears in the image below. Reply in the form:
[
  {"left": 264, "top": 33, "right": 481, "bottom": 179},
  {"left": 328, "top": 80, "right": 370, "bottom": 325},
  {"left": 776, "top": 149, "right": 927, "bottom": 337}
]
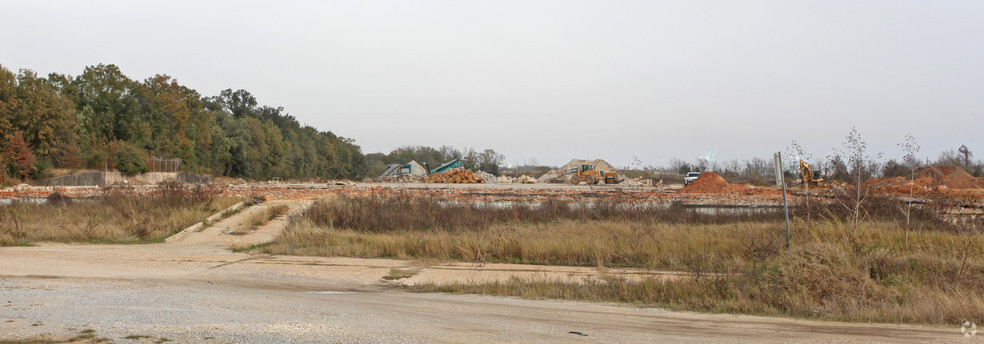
[{"left": 0, "top": 0, "right": 984, "bottom": 167}]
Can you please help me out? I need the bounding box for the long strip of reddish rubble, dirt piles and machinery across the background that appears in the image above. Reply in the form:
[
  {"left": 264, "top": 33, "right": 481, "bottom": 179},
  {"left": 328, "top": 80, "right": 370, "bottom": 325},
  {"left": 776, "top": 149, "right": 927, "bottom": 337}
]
[{"left": 7, "top": 159, "right": 984, "bottom": 223}]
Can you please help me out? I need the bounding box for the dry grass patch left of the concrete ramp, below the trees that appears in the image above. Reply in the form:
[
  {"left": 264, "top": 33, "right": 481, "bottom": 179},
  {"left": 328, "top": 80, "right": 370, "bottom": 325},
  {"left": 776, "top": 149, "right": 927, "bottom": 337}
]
[{"left": 0, "top": 183, "right": 239, "bottom": 246}]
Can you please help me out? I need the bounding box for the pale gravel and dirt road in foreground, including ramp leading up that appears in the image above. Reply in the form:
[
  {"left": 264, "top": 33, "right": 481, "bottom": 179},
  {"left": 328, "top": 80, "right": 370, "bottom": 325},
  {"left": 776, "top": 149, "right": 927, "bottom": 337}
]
[{"left": 0, "top": 201, "right": 974, "bottom": 343}]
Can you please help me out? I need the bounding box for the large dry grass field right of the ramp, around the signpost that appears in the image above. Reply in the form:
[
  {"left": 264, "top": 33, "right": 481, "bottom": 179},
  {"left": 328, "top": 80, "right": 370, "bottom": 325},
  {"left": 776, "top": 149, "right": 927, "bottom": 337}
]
[{"left": 262, "top": 197, "right": 984, "bottom": 324}]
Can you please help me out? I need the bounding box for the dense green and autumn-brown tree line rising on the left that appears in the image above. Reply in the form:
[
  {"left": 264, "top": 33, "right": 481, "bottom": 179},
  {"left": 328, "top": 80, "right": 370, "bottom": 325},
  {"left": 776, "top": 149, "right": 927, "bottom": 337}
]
[{"left": 0, "top": 64, "right": 368, "bottom": 180}]
